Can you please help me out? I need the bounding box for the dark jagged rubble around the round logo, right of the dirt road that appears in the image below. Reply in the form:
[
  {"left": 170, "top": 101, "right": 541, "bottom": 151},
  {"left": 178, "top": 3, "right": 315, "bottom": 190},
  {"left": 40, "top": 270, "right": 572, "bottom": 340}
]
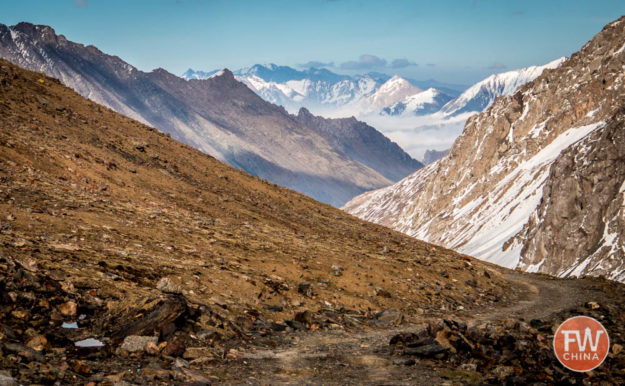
[{"left": 389, "top": 300, "right": 625, "bottom": 385}]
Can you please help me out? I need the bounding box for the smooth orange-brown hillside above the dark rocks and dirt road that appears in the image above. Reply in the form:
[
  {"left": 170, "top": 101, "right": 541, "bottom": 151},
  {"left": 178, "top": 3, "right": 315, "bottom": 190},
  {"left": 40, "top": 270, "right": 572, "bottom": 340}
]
[{"left": 0, "top": 61, "right": 506, "bottom": 332}]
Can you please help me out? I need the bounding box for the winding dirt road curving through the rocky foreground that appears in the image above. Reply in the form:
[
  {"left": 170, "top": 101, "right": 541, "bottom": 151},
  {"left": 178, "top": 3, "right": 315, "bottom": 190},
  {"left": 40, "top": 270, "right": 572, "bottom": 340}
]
[{"left": 212, "top": 272, "right": 602, "bottom": 385}]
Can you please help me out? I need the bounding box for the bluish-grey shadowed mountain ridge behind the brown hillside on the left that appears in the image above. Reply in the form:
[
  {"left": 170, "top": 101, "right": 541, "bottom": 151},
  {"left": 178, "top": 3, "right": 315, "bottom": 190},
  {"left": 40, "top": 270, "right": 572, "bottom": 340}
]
[{"left": 0, "top": 23, "right": 418, "bottom": 205}]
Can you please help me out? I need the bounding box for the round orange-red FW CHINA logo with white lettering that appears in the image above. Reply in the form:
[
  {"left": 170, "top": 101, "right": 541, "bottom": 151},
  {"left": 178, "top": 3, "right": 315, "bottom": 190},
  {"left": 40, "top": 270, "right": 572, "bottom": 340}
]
[{"left": 553, "top": 316, "right": 610, "bottom": 372}]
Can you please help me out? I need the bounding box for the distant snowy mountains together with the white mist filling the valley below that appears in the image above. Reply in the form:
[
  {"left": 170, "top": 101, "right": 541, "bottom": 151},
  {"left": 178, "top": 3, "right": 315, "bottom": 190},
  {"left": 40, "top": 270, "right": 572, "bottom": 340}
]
[{"left": 182, "top": 58, "right": 564, "bottom": 163}]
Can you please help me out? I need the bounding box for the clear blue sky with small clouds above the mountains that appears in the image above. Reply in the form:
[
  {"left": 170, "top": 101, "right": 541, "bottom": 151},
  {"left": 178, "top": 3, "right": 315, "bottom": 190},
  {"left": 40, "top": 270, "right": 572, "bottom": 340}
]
[{"left": 0, "top": 0, "right": 625, "bottom": 84}]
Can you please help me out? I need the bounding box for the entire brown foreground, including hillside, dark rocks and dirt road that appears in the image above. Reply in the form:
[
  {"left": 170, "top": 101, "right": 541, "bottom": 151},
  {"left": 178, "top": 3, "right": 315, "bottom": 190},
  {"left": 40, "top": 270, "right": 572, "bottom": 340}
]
[{"left": 0, "top": 56, "right": 625, "bottom": 385}]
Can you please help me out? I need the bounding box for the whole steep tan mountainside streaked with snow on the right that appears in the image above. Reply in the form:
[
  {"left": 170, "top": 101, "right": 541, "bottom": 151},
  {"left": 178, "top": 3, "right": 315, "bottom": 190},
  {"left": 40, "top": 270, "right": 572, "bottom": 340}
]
[{"left": 344, "top": 18, "right": 625, "bottom": 281}]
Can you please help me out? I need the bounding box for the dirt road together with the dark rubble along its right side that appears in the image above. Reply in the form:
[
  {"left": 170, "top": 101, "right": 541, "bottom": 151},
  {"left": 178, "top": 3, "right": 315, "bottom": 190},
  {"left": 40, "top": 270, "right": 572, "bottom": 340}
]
[{"left": 218, "top": 273, "right": 625, "bottom": 385}]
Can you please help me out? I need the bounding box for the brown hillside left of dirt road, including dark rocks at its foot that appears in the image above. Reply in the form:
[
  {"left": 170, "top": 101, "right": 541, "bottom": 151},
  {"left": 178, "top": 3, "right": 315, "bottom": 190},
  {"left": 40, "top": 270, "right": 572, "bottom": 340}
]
[{"left": 0, "top": 60, "right": 510, "bottom": 384}]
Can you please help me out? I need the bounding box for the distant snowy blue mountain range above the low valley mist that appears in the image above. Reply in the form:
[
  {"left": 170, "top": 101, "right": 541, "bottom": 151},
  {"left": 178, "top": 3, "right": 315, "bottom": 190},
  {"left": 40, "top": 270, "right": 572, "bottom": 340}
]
[{"left": 182, "top": 58, "right": 565, "bottom": 117}]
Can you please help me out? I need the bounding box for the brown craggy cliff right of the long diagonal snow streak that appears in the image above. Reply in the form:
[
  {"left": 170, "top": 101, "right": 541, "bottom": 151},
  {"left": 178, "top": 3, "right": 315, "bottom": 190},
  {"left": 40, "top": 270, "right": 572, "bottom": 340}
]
[{"left": 515, "top": 110, "right": 625, "bottom": 281}]
